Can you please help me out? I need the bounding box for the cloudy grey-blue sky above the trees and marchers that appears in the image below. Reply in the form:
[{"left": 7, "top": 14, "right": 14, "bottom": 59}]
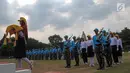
[{"left": 0, "top": 0, "right": 130, "bottom": 43}]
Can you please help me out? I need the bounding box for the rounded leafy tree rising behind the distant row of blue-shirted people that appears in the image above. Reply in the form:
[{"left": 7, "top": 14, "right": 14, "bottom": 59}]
[{"left": 48, "top": 34, "right": 63, "bottom": 47}]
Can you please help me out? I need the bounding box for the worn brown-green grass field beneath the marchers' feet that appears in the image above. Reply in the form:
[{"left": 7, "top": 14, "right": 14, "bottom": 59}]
[{"left": 0, "top": 53, "right": 130, "bottom": 73}]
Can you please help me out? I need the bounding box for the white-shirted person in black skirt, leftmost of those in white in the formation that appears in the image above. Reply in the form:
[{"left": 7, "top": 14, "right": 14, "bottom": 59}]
[{"left": 80, "top": 38, "right": 88, "bottom": 64}]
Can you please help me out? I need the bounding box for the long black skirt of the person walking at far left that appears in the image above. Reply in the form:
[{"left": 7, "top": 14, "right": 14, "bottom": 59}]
[{"left": 14, "top": 36, "right": 26, "bottom": 59}]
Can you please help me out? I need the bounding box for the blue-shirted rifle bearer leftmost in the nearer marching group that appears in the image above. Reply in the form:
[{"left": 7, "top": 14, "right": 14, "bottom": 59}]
[{"left": 63, "top": 35, "right": 71, "bottom": 68}]
